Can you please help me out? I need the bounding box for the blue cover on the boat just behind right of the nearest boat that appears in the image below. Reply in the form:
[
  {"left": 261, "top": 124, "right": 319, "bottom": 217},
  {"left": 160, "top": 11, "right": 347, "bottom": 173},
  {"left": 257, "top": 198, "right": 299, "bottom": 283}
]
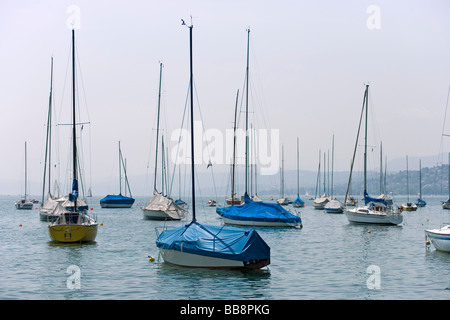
[{"left": 216, "top": 193, "right": 302, "bottom": 225}]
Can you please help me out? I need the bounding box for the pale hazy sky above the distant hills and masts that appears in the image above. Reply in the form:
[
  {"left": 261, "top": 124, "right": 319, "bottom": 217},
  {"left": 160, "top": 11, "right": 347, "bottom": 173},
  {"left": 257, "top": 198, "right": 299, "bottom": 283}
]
[{"left": 0, "top": 0, "right": 450, "bottom": 194}]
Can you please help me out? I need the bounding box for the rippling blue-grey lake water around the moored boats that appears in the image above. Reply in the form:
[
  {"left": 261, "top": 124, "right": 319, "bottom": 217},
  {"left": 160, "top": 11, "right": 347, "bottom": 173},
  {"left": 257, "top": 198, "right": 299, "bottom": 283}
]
[{"left": 0, "top": 196, "right": 450, "bottom": 300}]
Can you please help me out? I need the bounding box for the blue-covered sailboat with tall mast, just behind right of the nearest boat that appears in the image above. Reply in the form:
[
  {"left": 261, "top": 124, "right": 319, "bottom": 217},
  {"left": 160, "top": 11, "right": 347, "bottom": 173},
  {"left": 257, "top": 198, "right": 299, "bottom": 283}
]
[{"left": 216, "top": 29, "right": 302, "bottom": 227}]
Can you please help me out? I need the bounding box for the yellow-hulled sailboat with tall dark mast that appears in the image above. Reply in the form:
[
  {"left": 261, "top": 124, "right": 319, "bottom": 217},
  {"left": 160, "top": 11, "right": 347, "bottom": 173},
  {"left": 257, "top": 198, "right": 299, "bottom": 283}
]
[{"left": 48, "top": 29, "right": 98, "bottom": 242}]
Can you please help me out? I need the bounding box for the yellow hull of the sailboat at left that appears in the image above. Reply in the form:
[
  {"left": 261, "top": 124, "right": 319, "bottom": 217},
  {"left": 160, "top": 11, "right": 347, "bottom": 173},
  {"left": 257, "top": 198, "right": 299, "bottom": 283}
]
[{"left": 48, "top": 224, "right": 98, "bottom": 242}]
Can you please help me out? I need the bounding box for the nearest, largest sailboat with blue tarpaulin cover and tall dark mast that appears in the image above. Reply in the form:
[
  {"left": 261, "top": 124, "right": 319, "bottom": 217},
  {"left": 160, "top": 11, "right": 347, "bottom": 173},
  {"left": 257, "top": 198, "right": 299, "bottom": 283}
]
[{"left": 156, "top": 21, "right": 270, "bottom": 269}]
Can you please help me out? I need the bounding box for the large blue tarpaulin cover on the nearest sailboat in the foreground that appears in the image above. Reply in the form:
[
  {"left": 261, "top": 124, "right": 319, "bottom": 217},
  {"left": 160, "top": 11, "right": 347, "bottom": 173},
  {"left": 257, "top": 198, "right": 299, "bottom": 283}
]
[{"left": 156, "top": 221, "right": 270, "bottom": 262}]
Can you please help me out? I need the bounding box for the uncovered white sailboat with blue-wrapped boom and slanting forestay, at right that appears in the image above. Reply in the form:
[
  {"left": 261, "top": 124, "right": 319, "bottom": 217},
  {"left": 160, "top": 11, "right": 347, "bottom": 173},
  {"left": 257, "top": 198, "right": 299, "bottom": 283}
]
[{"left": 344, "top": 85, "right": 403, "bottom": 225}]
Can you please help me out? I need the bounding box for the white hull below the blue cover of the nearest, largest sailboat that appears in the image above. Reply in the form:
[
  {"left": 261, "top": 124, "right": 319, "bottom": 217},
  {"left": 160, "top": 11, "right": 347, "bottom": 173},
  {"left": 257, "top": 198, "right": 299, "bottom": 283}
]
[{"left": 159, "top": 248, "right": 245, "bottom": 268}]
